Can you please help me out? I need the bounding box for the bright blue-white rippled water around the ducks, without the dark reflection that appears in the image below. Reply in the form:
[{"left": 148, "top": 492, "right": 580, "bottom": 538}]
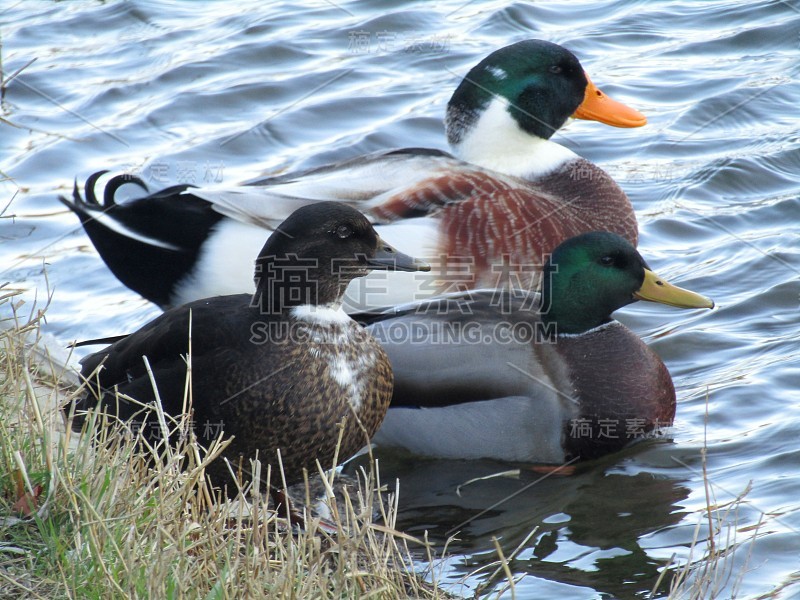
[{"left": 0, "top": 0, "right": 800, "bottom": 598}]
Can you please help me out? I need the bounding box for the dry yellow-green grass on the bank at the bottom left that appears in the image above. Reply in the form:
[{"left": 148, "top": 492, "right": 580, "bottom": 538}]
[{"left": 0, "top": 290, "right": 447, "bottom": 599}]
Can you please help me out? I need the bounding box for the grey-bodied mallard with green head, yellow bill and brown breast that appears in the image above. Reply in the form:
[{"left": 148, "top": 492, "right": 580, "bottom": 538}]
[{"left": 353, "top": 232, "right": 714, "bottom": 465}]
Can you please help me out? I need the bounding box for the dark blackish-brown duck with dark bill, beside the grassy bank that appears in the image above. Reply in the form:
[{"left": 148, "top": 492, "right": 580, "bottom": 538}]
[{"left": 69, "top": 202, "right": 429, "bottom": 493}]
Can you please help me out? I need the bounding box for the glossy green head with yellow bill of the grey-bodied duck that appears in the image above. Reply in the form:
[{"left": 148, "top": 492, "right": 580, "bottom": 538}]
[{"left": 541, "top": 231, "right": 714, "bottom": 334}]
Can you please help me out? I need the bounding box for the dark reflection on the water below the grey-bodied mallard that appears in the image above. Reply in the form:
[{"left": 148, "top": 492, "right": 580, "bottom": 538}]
[{"left": 348, "top": 450, "right": 689, "bottom": 598}]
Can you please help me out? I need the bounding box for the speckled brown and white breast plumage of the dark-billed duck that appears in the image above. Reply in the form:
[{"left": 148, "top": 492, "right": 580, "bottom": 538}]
[{"left": 189, "top": 304, "right": 392, "bottom": 482}]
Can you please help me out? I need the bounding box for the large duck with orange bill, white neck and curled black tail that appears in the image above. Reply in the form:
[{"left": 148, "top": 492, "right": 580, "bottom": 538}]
[{"left": 61, "top": 39, "right": 647, "bottom": 311}]
